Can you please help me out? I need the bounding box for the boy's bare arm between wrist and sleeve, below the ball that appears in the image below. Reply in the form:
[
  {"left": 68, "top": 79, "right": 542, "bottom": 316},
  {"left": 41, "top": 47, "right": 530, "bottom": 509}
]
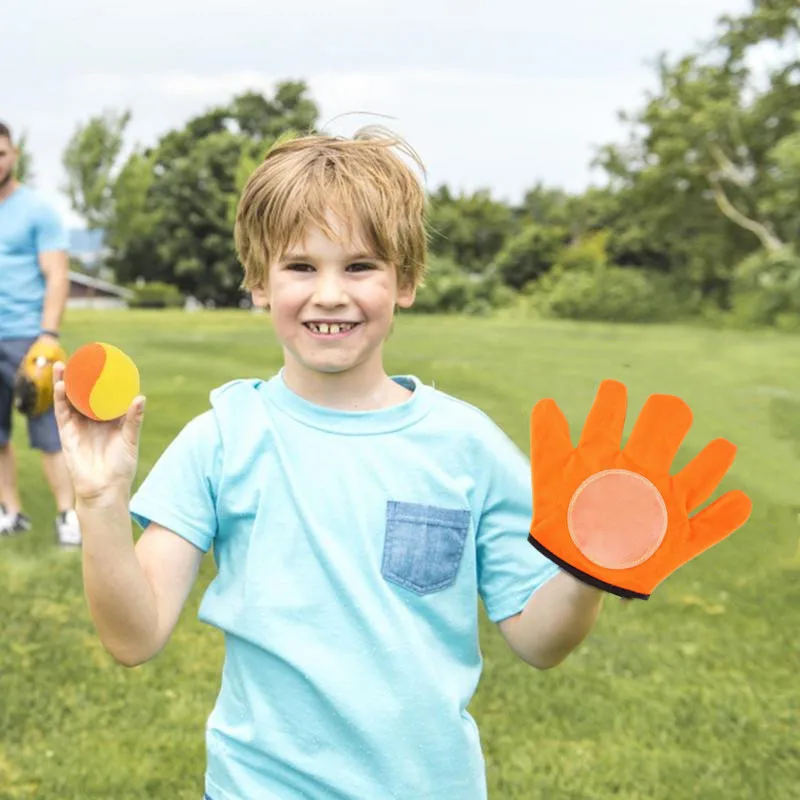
[{"left": 76, "top": 493, "right": 203, "bottom": 667}]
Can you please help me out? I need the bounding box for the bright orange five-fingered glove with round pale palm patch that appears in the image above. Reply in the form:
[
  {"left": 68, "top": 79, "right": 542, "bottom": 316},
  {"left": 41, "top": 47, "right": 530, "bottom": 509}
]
[{"left": 528, "top": 380, "right": 752, "bottom": 600}]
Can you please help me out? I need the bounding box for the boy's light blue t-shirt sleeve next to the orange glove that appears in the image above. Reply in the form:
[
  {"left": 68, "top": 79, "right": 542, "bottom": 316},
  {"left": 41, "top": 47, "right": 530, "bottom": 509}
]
[{"left": 476, "top": 428, "right": 559, "bottom": 622}]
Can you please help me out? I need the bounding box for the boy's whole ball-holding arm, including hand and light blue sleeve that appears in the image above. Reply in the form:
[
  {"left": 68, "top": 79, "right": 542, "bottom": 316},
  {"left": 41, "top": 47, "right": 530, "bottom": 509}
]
[{"left": 53, "top": 363, "right": 216, "bottom": 666}]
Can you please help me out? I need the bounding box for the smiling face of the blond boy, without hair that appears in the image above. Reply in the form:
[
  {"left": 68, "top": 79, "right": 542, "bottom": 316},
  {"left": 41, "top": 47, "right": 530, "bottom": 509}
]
[{"left": 253, "top": 214, "right": 415, "bottom": 388}]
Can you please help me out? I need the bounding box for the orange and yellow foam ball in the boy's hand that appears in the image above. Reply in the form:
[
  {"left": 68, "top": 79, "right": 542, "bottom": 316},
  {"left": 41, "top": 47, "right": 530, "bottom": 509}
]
[{"left": 64, "top": 342, "right": 139, "bottom": 422}]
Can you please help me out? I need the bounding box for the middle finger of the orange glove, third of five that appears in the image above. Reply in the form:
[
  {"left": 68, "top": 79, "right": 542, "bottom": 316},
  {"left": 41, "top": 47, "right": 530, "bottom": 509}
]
[{"left": 623, "top": 394, "right": 692, "bottom": 474}]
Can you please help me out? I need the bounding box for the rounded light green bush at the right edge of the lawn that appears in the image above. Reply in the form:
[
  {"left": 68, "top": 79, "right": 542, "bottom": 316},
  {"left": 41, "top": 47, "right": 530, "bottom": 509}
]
[{"left": 731, "top": 247, "right": 800, "bottom": 329}]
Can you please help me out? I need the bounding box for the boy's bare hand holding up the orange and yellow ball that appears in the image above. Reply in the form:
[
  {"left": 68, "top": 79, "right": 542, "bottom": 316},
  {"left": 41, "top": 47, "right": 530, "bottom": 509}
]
[{"left": 53, "top": 362, "right": 145, "bottom": 505}]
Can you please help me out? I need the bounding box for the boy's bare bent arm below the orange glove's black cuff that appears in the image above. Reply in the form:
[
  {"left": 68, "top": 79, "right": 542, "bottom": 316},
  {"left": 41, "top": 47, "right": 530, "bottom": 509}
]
[{"left": 498, "top": 571, "right": 605, "bottom": 669}]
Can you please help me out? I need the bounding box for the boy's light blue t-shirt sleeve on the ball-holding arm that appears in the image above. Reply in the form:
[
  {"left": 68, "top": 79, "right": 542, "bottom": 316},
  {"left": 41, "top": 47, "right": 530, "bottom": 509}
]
[{"left": 130, "top": 411, "right": 222, "bottom": 552}]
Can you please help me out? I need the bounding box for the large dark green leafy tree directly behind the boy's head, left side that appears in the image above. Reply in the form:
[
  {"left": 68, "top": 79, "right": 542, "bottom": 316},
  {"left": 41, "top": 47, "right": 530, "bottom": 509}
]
[{"left": 101, "top": 82, "right": 317, "bottom": 305}]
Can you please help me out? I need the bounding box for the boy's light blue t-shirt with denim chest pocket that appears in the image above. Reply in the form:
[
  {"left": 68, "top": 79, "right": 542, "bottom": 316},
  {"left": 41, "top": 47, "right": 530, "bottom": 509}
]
[{"left": 131, "top": 374, "right": 558, "bottom": 800}]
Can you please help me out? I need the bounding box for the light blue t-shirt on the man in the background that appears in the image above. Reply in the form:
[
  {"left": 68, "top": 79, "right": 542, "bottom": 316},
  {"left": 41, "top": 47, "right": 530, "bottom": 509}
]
[{"left": 0, "top": 186, "right": 69, "bottom": 339}]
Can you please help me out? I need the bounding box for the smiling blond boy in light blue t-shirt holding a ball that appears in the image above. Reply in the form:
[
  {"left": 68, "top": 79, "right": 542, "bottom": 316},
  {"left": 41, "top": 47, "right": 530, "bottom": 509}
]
[{"left": 56, "top": 128, "right": 602, "bottom": 800}]
